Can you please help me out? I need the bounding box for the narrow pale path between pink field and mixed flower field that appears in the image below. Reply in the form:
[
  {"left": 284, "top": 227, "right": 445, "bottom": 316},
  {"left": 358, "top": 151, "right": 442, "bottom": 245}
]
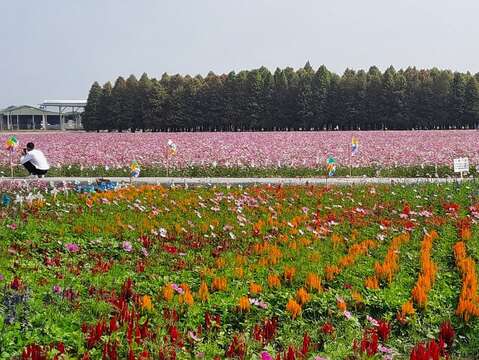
[{"left": 0, "top": 177, "right": 474, "bottom": 185}]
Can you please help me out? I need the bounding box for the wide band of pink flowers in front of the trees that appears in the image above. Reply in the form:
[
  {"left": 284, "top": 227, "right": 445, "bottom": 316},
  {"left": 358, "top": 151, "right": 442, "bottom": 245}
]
[{"left": 0, "top": 130, "right": 479, "bottom": 168}]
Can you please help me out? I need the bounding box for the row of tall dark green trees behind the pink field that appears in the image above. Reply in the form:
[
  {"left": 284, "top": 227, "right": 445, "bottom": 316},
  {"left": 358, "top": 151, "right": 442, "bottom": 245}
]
[{"left": 83, "top": 63, "right": 479, "bottom": 131}]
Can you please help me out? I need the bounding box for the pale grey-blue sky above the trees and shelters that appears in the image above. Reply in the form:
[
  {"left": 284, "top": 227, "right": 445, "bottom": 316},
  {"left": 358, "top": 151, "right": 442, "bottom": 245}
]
[{"left": 0, "top": 0, "right": 479, "bottom": 107}]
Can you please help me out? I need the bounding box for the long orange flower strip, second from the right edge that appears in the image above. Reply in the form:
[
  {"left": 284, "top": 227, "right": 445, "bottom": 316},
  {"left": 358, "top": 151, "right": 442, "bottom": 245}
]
[{"left": 412, "top": 230, "right": 438, "bottom": 307}]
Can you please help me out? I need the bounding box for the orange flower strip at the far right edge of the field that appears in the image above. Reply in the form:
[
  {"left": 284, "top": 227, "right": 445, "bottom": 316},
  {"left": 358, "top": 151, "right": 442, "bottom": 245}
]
[{"left": 454, "top": 241, "right": 479, "bottom": 321}]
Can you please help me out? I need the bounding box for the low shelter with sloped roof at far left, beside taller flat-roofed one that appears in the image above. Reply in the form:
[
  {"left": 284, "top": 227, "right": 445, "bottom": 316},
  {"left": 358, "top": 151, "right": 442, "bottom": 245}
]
[{"left": 0, "top": 105, "right": 60, "bottom": 131}]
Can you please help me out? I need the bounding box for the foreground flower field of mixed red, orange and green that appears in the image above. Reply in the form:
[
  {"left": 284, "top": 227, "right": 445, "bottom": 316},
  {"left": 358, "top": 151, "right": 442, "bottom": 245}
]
[{"left": 0, "top": 183, "right": 479, "bottom": 360}]
